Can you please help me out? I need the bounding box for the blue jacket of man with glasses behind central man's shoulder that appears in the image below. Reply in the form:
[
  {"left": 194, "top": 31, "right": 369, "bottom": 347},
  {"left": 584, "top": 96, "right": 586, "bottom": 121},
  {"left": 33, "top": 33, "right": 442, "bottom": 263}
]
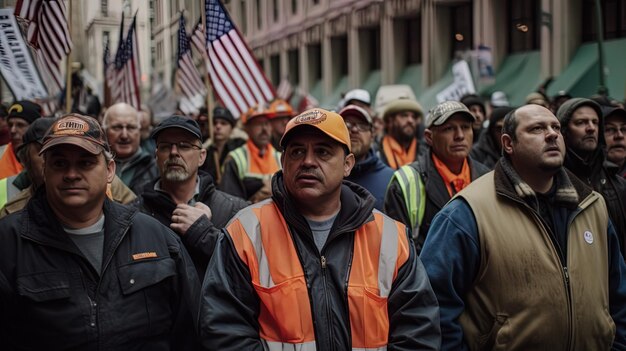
[{"left": 346, "top": 149, "right": 393, "bottom": 211}]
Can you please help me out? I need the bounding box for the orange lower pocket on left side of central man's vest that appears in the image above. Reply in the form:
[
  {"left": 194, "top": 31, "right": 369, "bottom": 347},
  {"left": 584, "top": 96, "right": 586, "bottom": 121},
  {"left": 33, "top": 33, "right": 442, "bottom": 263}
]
[{"left": 252, "top": 276, "right": 315, "bottom": 343}]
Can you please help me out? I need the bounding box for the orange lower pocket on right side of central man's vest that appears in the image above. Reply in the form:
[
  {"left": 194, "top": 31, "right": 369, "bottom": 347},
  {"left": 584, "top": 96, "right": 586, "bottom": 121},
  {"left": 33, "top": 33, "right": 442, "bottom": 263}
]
[{"left": 348, "top": 286, "right": 389, "bottom": 348}]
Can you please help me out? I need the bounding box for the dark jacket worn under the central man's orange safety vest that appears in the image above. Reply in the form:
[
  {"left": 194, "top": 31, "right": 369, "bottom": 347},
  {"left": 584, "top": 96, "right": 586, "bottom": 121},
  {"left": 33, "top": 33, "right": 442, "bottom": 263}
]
[{"left": 199, "top": 171, "right": 440, "bottom": 351}]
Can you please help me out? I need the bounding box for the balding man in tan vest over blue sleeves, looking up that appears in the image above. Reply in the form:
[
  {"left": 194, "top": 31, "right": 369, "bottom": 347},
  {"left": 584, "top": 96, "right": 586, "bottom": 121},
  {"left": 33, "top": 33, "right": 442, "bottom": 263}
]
[{"left": 421, "top": 105, "right": 626, "bottom": 350}]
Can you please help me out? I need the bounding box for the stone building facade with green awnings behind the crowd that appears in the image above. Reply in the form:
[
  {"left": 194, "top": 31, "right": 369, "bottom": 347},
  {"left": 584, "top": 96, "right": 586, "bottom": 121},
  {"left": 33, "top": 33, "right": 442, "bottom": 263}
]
[{"left": 225, "top": 0, "right": 626, "bottom": 112}]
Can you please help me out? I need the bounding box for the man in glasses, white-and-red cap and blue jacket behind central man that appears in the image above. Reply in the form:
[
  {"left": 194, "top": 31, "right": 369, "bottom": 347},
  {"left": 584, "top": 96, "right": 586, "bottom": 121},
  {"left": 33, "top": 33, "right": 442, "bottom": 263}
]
[{"left": 339, "top": 105, "right": 393, "bottom": 211}]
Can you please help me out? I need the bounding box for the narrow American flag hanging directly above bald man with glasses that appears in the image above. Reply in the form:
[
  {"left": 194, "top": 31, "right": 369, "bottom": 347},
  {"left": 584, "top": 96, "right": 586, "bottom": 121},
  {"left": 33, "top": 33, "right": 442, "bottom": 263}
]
[{"left": 114, "top": 14, "right": 141, "bottom": 110}]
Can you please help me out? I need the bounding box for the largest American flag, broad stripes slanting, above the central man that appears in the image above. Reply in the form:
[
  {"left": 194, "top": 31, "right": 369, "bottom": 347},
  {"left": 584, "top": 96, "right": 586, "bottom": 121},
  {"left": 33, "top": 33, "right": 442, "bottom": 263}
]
[{"left": 205, "top": 0, "right": 275, "bottom": 116}]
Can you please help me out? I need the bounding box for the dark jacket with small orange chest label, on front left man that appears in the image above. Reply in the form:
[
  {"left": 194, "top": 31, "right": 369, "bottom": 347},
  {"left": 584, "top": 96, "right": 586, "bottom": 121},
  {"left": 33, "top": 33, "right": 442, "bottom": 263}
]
[{"left": 0, "top": 187, "right": 199, "bottom": 350}]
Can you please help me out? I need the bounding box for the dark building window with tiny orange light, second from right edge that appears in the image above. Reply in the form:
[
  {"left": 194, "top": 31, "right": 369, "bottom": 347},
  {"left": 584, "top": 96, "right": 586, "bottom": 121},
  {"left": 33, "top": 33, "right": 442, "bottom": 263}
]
[{"left": 508, "top": 0, "right": 540, "bottom": 53}]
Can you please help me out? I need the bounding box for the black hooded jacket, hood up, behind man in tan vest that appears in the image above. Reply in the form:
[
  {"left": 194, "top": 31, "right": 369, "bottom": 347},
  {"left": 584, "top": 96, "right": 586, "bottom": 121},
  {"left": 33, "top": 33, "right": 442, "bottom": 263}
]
[{"left": 557, "top": 98, "right": 626, "bottom": 257}]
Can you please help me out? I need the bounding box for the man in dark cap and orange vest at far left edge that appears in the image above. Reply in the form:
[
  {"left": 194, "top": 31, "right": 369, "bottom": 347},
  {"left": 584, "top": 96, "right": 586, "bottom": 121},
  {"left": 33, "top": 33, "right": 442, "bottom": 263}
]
[{"left": 0, "top": 101, "right": 41, "bottom": 179}]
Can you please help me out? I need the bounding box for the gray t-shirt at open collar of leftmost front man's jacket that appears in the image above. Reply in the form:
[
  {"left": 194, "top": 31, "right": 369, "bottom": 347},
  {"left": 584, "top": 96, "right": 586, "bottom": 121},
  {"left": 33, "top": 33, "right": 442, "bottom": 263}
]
[{"left": 63, "top": 215, "right": 104, "bottom": 274}]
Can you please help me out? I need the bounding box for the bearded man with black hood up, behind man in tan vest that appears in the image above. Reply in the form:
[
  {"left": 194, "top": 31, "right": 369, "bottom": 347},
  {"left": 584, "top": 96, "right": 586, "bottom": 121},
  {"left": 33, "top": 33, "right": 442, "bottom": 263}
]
[{"left": 556, "top": 98, "right": 626, "bottom": 255}]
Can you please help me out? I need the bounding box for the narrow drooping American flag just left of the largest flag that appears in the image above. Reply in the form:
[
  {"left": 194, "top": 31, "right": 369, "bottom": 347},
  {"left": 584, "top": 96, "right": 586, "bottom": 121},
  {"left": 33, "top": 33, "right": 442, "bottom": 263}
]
[{"left": 176, "top": 13, "right": 206, "bottom": 113}]
